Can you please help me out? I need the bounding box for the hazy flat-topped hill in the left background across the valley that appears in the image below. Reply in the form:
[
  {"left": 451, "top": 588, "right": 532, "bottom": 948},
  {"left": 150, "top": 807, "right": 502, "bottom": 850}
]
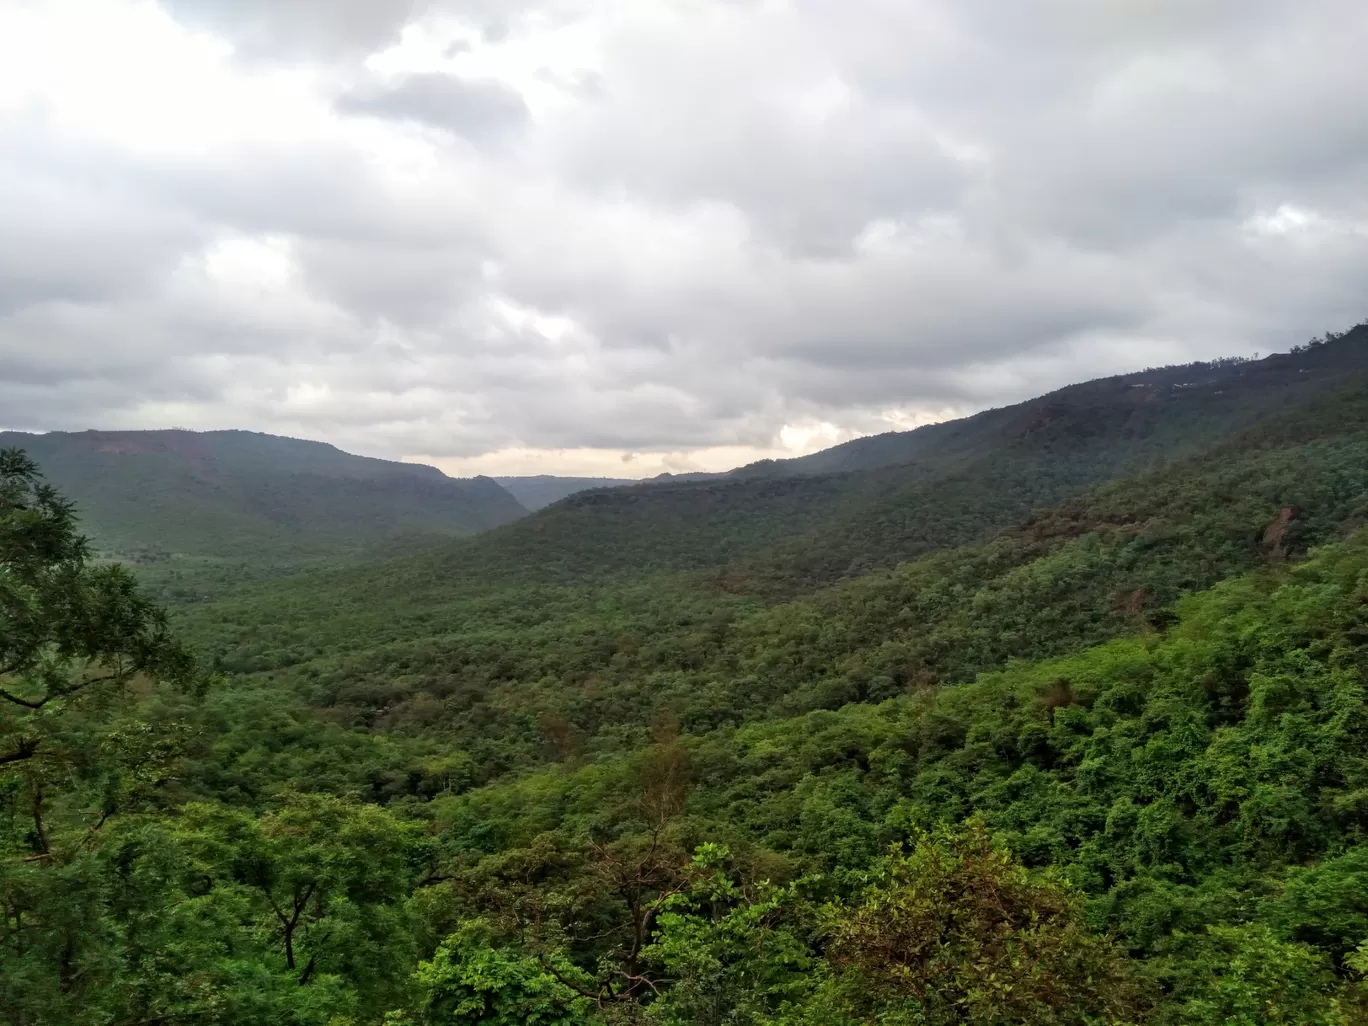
[{"left": 0, "top": 431, "right": 527, "bottom": 562}]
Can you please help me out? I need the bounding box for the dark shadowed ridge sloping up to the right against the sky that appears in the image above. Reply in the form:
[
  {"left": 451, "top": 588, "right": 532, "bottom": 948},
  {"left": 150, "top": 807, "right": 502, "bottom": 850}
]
[{"left": 328, "top": 327, "right": 1368, "bottom": 594}]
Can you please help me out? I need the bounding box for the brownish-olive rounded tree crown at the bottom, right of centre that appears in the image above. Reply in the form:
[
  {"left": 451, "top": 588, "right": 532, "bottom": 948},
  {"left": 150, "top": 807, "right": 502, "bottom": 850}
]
[{"left": 828, "top": 821, "right": 1141, "bottom": 1026}]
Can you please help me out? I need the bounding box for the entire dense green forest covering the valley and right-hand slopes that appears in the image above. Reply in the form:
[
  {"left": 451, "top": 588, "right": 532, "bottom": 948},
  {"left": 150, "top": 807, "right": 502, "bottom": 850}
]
[{"left": 8, "top": 326, "right": 1368, "bottom": 1026}]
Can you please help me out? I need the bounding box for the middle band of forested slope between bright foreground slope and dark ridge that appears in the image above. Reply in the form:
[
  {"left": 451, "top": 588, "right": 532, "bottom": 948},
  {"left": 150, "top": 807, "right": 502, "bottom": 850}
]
[{"left": 181, "top": 374, "right": 1368, "bottom": 777}]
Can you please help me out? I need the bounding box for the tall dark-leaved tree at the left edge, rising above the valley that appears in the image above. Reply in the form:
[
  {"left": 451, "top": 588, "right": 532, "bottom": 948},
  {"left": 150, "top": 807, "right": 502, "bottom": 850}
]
[{"left": 0, "top": 449, "right": 196, "bottom": 1023}]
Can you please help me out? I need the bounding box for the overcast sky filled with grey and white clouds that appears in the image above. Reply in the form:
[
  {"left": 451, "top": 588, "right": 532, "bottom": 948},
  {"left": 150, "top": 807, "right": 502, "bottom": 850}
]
[{"left": 0, "top": 0, "right": 1368, "bottom": 477}]
